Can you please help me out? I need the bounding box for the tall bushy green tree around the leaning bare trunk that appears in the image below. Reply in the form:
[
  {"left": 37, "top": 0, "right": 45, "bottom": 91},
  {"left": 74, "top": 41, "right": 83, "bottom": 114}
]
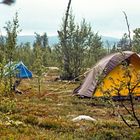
[{"left": 56, "top": 12, "right": 102, "bottom": 80}]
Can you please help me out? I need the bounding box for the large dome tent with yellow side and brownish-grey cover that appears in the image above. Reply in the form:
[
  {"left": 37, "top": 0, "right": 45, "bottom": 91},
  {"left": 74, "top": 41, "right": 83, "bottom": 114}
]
[{"left": 74, "top": 51, "right": 140, "bottom": 97}]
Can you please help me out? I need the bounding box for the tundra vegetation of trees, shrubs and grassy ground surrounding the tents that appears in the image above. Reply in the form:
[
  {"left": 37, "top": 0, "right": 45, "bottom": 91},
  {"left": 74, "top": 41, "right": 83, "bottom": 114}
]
[{"left": 0, "top": 1, "right": 140, "bottom": 140}]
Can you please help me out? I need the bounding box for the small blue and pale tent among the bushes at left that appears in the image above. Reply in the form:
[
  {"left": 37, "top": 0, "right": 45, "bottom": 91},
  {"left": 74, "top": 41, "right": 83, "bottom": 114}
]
[{"left": 5, "top": 61, "right": 32, "bottom": 79}]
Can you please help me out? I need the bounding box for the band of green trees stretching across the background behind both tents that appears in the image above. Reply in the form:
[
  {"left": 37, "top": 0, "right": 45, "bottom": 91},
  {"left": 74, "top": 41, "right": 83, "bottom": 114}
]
[{"left": 0, "top": 12, "right": 140, "bottom": 80}]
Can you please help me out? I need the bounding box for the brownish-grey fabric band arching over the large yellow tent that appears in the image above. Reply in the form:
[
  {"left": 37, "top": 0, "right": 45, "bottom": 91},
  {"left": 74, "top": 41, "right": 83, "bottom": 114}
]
[{"left": 76, "top": 51, "right": 140, "bottom": 97}]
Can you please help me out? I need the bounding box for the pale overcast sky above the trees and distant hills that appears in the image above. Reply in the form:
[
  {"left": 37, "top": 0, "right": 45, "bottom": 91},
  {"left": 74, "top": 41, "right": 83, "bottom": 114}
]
[{"left": 0, "top": 0, "right": 140, "bottom": 38}]
